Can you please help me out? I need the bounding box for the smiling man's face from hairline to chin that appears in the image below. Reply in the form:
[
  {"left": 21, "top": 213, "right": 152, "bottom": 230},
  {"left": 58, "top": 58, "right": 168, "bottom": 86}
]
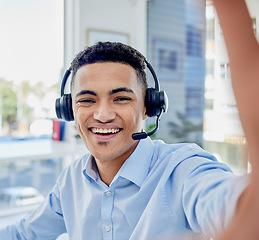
[{"left": 72, "top": 62, "right": 147, "bottom": 163}]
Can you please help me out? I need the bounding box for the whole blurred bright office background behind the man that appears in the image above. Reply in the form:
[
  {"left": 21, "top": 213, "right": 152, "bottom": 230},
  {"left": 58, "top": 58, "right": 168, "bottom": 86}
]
[{"left": 0, "top": 0, "right": 259, "bottom": 236}]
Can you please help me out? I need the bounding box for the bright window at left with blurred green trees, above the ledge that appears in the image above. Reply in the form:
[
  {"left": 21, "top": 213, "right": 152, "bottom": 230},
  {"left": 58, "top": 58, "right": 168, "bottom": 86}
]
[{"left": 0, "top": 0, "right": 63, "bottom": 141}]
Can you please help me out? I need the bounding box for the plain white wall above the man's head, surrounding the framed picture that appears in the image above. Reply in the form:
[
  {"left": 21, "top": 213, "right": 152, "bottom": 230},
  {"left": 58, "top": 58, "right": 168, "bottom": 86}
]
[{"left": 64, "top": 0, "right": 147, "bottom": 68}]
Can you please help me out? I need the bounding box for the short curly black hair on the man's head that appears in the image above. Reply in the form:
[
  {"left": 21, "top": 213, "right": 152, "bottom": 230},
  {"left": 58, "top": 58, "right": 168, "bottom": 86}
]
[{"left": 71, "top": 42, "right": 148, "bottom": 93}]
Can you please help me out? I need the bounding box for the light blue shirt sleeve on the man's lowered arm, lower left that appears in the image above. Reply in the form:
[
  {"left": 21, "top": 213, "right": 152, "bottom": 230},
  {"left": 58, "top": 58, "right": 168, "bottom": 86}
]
[{"left": 0, "top": 185, "right": 66, "bottom": 240}]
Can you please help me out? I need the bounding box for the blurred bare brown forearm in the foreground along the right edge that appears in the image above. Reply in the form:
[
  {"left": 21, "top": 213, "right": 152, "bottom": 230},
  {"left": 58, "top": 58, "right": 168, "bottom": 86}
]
[{"left": 214, "top": 0, "right": 259, "bottom": 240}]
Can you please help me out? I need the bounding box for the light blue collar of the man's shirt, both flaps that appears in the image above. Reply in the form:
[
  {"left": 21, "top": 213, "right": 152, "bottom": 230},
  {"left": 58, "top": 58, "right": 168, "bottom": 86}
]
[{"left": 83, "top": 137, "right": 154, "bottom": 187}]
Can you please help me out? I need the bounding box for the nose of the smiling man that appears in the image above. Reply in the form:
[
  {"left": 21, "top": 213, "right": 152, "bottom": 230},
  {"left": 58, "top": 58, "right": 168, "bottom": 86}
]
[{"left": 93, "top": 102, "right": 116, "bottom": 123}]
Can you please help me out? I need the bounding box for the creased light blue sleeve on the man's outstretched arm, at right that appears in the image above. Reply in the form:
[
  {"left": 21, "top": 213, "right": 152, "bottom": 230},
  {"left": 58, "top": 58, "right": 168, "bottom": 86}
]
[{"left": 182, "top": 158, "right": 249, "bottom": 237}]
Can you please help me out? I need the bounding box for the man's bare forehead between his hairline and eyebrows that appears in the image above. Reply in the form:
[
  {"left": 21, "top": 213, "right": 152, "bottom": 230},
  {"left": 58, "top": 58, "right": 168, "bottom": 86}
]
[{"left": 72, "top": 62, "right": 141, "bottom": 90}]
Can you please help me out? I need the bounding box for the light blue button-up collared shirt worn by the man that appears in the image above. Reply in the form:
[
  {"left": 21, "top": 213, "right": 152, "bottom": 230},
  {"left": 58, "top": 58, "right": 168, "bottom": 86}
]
[{"left": 0, "top": 138, "right": 248, "bottom": 240}]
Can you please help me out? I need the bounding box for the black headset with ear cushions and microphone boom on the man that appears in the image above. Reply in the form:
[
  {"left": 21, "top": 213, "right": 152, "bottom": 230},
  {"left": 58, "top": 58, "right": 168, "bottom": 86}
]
[{"left": 55, "top": 59, "right": 168, "bottom": 140}]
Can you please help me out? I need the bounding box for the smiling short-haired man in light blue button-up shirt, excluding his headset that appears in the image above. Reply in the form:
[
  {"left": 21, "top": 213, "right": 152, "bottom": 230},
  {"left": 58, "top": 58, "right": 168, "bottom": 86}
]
[{"left": 0, "top": 42, "right": 251, "bottom": 240}]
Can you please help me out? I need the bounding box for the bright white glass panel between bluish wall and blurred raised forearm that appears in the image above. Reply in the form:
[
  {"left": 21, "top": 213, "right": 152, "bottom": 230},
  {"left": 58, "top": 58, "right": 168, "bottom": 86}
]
[{"left": 203, "top": 0, "right": 249, "bottom": 174}]
